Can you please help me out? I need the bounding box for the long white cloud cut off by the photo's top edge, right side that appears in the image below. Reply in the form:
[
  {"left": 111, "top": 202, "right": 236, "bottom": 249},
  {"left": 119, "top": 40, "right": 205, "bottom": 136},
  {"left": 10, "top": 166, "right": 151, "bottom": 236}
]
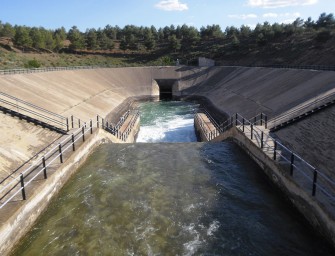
[{"left": 247, "top": 0, "right": 319, "bottom": 8}]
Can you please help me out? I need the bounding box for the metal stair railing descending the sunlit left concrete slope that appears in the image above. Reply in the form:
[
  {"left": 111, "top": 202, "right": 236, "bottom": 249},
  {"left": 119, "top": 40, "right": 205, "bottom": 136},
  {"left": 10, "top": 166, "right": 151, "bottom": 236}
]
[{"left": 0, "top": 92, "right": 69, "bottom": 131}]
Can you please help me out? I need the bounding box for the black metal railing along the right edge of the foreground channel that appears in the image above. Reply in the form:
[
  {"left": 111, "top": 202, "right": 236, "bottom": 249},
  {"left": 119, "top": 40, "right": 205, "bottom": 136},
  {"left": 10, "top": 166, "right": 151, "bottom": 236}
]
[{"left": 195, "top": 108, "right": 335, "bottom": 210}]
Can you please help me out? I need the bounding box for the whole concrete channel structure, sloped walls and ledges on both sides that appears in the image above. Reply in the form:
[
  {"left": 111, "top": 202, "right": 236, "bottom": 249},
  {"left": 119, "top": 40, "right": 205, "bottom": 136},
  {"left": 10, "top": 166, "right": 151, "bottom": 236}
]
[{"left": 0, "top": 67, "right": 335, "bottom": 255}]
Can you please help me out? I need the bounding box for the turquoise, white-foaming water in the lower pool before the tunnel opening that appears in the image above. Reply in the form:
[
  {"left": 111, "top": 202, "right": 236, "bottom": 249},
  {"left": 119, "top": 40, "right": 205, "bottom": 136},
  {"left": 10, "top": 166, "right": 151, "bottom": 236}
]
[{"left": 136, "top": 101, "right": 199, "bottom": 142}]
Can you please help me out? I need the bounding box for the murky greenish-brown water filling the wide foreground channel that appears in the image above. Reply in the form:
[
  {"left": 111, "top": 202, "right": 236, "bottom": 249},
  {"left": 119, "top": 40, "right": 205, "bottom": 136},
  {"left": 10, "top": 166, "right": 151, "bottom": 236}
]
[{"left": 14, "top": 100, "right": 334, "bottom": 255}]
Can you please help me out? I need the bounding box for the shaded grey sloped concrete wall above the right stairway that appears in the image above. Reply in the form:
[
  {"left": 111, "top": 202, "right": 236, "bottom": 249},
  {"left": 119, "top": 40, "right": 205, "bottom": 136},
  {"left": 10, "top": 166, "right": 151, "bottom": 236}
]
[{"left": 179, "top": 67, "right": 335, "bottom": 118}]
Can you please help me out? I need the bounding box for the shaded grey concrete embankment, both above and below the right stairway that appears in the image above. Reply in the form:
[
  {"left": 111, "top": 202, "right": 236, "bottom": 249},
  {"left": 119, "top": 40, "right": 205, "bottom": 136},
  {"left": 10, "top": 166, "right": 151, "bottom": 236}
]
[{"left": 178, "top": 67, "right": 335, "bottom": 175}]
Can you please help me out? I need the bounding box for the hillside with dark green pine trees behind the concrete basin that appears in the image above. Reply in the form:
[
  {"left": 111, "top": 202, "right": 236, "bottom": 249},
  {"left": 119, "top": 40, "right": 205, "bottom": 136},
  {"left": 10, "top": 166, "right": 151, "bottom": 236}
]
[{"left": 0, "top": 13, "right": 335, "bottom": 69}]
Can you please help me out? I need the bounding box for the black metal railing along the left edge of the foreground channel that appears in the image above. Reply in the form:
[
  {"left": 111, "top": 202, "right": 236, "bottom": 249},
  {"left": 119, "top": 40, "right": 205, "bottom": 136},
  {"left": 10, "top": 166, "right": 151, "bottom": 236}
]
[{"left": 0, "top": 106, "right": 139, "bottom": 209}]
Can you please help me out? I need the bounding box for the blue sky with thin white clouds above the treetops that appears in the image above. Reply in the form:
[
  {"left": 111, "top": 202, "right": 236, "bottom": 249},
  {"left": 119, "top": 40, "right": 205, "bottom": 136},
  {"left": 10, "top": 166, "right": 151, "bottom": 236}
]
[{"left": 0, "top": 0, "right": 335, "bottom": 32}]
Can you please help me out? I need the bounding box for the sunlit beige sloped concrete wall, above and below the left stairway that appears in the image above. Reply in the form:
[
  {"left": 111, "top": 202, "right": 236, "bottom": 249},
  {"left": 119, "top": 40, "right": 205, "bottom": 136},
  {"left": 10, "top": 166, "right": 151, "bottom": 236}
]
[{"left": 0, "top": 67, "right": 181, "bottom": 178}]
